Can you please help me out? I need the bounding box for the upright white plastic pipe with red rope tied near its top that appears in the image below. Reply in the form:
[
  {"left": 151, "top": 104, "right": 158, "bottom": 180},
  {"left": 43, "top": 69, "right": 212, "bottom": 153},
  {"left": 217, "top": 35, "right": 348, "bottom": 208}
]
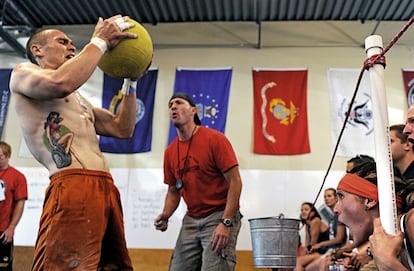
[{"left": 365, "top": 35, "right": 397, "bottom": 234}]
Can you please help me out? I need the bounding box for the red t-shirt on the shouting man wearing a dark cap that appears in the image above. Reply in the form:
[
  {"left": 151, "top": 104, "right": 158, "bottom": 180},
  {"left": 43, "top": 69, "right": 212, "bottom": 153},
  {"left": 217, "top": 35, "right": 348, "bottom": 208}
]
[{"left": 164, "top": 126, "right": 238, "bottom": 217}]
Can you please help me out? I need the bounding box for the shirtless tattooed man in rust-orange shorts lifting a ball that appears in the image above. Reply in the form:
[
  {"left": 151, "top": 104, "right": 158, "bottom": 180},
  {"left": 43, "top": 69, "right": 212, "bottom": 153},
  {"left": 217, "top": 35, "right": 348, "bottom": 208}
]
[{"left": 10, "top": 15, "right": 143, "bottom": 270}]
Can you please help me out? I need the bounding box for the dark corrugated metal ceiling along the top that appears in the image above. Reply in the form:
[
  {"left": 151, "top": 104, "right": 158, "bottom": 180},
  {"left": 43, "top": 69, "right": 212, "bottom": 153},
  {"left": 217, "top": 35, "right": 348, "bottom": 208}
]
[{"left": 0, "top": 0, "right": 414, "bottom": 54}]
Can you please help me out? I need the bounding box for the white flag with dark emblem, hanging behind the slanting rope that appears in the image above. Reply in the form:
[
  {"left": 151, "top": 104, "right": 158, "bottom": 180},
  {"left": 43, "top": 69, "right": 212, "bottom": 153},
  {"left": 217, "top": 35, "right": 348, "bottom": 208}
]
[{"left": 328, "top": 68, "right": 375, "bottom": 157}]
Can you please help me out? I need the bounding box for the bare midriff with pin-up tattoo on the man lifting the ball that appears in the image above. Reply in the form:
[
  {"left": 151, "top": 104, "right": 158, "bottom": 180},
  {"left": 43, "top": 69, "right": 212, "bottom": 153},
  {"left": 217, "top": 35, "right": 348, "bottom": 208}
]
[{"left": 13, "top": 92, "right": 109, "bottom": 175}]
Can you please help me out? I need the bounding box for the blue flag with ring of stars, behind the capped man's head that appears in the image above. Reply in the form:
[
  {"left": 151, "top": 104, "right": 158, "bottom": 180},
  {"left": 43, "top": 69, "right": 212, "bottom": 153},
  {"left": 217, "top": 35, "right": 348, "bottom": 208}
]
[{"left": 168, "top": 67, "right": 233, "bottom": 144}]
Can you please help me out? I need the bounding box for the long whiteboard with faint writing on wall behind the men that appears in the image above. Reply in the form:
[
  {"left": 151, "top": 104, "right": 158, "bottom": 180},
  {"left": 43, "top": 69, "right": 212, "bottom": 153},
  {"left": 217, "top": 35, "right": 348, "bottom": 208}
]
[{"left": 14, "top": 167, "right": 344, "bottom": 250}]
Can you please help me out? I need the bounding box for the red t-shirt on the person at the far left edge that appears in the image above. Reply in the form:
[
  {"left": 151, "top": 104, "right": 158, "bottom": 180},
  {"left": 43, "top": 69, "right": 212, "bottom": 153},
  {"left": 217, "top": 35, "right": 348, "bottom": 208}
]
[{"left": 0, "top": 167, "right": 27, "bottom": 232}]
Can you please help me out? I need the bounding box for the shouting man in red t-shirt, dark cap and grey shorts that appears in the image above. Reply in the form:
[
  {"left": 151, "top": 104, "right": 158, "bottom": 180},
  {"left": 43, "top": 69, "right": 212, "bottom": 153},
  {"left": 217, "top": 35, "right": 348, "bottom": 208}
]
[{"left": 154, "top": 93, "right": 242, "bottom": 271}]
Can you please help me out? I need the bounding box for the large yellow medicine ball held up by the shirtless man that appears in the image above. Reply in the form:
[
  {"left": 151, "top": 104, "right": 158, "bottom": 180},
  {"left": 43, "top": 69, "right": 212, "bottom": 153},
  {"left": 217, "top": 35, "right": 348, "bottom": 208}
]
[{"left": 98, "top": 19, "right": 154, "bottom": 78}]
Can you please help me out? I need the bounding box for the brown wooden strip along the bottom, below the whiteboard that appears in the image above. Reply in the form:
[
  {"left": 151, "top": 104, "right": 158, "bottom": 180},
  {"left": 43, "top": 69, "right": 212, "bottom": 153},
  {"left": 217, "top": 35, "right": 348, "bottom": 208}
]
[{"left": 14, "top": 249, "right": 278, "bottom": 271}]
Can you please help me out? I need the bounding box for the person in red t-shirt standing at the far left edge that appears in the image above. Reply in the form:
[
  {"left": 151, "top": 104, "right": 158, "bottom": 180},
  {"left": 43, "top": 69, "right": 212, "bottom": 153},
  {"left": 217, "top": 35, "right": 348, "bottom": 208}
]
[{"left": 0, "top": 141, "right": 27, "bottom": 271}]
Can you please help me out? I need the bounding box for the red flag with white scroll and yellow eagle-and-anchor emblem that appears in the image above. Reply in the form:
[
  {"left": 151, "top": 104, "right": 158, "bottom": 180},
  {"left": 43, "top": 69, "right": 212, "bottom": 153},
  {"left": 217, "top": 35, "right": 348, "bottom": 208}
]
[{"left": 252, "top": 68, "right": 310, "bottom": 155}]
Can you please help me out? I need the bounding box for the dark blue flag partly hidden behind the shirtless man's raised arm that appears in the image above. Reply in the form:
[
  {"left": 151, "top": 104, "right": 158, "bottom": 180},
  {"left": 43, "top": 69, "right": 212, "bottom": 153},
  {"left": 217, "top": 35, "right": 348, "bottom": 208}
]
[{"left": 99, "top": 68, "right": 158, "bottom": 153}]
